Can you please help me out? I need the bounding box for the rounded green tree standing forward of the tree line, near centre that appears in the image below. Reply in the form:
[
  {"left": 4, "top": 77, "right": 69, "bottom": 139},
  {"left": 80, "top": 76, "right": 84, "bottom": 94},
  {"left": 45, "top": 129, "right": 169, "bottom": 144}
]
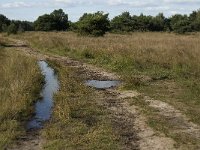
[{"left": 77, "top": 12, "right": 110, "bottom": 36}]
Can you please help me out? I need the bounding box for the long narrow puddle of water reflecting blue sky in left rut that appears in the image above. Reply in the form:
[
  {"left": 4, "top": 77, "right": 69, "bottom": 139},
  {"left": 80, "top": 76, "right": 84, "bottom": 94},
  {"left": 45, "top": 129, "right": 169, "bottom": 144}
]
[{"left": 27, "top": 61, "right": 59, "bottom": 130}]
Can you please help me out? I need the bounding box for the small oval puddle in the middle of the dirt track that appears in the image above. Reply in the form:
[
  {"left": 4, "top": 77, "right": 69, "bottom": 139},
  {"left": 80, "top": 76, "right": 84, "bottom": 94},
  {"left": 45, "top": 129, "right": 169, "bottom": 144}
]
[{"left": 86, "top": 80, "right": 120, "bottom": 89}]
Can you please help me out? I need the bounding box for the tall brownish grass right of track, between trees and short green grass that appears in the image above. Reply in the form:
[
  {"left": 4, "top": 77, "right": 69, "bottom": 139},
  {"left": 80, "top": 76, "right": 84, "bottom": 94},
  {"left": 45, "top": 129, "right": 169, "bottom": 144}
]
[{"left": 12, "top": 32, "right": 200, "bottom": 78}]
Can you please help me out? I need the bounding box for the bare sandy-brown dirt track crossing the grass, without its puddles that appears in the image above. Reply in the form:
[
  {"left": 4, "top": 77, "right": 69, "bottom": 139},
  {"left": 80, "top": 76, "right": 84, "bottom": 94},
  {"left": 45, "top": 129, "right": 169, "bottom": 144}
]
[{"left": 6, "top": 40, "right": 200, "bottom": 150}]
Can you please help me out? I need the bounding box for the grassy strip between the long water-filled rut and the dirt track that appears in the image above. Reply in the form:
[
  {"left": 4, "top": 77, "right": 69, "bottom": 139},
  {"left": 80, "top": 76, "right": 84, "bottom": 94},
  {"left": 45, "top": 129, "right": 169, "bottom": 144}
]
[{"left": 42, "top": 62, "right": 121, "bottom": 150}]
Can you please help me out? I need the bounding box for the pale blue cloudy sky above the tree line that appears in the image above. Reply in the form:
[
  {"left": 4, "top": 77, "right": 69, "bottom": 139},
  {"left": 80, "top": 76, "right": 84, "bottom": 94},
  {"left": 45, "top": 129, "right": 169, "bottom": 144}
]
[{"left": 0, "top": 0, "right": 200, "bottom": 21}]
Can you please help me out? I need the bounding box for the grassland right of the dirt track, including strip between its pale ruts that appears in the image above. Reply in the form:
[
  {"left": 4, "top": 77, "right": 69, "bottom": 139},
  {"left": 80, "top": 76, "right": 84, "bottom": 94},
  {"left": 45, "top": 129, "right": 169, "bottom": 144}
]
[{"left": 9, "top": 32, "right": 200, "bottom": 148}]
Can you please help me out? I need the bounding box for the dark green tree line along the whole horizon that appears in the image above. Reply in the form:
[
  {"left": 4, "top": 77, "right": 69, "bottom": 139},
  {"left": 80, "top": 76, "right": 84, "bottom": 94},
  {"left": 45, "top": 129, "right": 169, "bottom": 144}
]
[{"left": 0, "top": 9, "right": 200, "bottom": 36}]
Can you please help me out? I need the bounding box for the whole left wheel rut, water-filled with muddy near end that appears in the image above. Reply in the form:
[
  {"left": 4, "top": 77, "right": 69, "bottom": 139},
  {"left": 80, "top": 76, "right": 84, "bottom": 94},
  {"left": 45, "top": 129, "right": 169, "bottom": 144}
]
[{"left": 8, "top": 61, "right": 59, "bottom": 150}]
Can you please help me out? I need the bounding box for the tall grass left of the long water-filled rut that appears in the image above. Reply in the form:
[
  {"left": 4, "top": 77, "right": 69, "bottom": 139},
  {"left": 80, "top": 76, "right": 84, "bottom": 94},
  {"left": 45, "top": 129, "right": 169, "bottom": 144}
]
[{"left": 0, "top": 38, "right": 42, "bottom": 149}]
